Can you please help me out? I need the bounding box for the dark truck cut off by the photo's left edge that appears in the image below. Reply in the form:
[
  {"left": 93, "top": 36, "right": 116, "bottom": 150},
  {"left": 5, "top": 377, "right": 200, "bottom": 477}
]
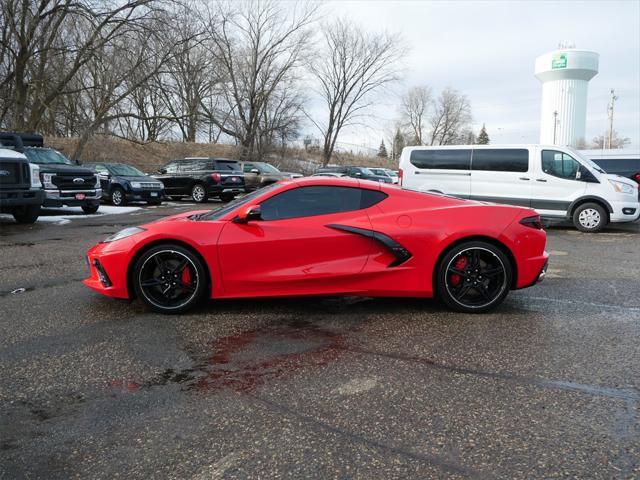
[{"left": 0, "top": 148, "right": 44, "bottom": 223}]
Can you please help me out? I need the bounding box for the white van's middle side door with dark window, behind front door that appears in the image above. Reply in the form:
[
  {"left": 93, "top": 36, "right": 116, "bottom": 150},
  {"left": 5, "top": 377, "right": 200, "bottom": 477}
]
[{"left": 471, "top": 147, "right": 535, "bottom": 207}]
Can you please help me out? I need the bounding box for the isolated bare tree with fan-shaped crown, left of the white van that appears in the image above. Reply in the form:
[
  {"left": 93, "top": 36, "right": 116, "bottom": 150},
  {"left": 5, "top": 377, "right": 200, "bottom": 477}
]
[{"left": 311, "top": 20, "right": 404, "bottom": 165}]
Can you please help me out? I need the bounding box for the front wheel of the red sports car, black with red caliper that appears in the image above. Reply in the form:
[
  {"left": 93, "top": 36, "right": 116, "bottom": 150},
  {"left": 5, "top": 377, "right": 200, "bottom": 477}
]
[{"left": 131, "top": 243, "right": 208, "bottom": 314}]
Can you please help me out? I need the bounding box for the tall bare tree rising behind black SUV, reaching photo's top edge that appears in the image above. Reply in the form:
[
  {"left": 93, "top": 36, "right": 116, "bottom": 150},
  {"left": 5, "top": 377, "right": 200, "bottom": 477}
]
[{"left": 208, "top": 0, "right": 317, "bottom": 158}]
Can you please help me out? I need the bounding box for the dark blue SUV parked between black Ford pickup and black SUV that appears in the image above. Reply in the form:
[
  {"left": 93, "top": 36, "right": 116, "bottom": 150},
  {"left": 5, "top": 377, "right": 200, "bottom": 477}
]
[{"left": 85, "top": 163, "right": 164, "bottom": 207}]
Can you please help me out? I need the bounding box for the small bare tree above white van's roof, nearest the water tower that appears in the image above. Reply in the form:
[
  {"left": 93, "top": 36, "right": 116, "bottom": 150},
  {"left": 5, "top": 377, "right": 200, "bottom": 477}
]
[{"left": 429, "top": 88, "right": 471, "bottom": 145}]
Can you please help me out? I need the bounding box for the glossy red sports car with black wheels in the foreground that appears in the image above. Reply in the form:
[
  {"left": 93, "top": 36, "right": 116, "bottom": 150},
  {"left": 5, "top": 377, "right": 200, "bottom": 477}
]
[{"left": 84, "top": 177, "right": 548, "bottom": 313}]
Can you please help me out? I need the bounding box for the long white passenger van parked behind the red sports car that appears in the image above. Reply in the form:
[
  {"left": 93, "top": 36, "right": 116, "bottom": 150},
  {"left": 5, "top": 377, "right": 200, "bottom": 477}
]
[{"left": 400, "top": 145, "right": 640, "bottom": 232}]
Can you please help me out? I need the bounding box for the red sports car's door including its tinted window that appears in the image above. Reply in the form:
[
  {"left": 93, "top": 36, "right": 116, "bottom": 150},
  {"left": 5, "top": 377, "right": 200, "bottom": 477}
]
[{"left": 218, "top": 186, "right": 373, "bottom": 296}]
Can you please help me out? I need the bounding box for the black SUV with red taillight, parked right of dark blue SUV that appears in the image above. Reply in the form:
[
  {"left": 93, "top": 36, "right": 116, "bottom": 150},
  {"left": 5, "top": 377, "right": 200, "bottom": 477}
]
[{"left": 153, "top": 158, "right": 244, "bottom": 203}]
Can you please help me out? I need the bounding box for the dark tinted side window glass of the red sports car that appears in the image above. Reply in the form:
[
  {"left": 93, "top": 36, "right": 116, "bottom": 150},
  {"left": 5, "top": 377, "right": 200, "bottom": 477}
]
[{"left": 260, "top": 185, "right": 362, "bottom": 220}]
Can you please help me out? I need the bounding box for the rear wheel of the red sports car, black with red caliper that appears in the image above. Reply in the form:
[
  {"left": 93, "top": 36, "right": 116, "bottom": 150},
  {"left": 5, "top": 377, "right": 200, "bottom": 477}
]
[{"left": 435, "top": 241, "right": 513, "bottom": 313}]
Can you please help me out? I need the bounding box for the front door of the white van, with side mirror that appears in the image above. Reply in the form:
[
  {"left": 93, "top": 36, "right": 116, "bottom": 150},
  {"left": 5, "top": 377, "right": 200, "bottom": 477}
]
[{"left": 531, "top": 148, "right": 587, "bottom": 217}]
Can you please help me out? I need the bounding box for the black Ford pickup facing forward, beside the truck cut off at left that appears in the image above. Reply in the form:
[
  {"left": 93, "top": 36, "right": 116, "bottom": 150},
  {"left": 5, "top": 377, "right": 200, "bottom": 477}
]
[{"left": 0, "top": 132, "right": 102, "bottom": 213}]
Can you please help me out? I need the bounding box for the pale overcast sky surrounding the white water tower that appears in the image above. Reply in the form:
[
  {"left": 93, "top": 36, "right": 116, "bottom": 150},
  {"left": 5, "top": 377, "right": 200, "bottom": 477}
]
[{"left": 318, "top": 0, "right": 640, "bottom": 152}]
